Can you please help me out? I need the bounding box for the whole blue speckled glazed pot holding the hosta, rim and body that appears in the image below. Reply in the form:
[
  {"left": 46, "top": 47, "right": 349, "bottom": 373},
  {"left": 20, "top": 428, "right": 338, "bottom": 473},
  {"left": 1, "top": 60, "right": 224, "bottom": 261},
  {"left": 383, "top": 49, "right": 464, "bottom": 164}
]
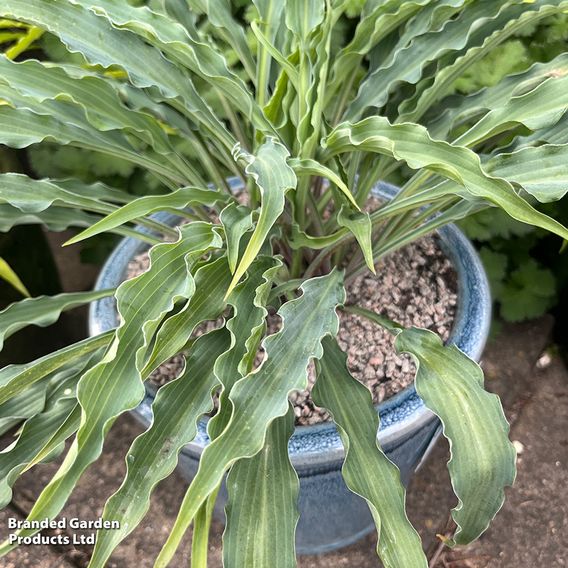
[{"left": 89, "top": 183, "right": 491, "bottom": 554}]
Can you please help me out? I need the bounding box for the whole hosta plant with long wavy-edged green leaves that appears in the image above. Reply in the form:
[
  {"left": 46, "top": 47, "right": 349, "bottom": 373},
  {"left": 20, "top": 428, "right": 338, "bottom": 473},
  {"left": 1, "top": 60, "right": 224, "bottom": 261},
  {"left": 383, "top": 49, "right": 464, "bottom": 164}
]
[{"left": 0, "top": 0, "right": 568, "bottom": 568}]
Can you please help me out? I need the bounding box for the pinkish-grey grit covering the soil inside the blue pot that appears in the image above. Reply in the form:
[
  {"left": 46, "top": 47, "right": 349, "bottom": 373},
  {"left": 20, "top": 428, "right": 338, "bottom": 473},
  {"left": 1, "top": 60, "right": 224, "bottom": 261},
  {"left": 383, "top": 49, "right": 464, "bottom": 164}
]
[{"left": 127, "top": 237, "right": 457, "bottom": 426}]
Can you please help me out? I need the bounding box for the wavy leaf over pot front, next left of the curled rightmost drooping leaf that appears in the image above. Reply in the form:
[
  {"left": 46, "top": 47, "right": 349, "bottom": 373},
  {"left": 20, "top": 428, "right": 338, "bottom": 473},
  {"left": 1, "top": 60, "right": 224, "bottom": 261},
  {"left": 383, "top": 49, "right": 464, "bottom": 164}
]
[{"left": 312, "top": 337, "right": 427, "bottom": 568}]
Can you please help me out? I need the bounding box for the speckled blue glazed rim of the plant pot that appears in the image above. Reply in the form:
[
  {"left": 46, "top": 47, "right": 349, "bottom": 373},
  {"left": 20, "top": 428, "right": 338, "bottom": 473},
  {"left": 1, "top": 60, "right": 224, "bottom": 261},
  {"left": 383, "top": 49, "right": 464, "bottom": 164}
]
[{"left": 89, "top": 179, "right": 491, "bottom": 467}]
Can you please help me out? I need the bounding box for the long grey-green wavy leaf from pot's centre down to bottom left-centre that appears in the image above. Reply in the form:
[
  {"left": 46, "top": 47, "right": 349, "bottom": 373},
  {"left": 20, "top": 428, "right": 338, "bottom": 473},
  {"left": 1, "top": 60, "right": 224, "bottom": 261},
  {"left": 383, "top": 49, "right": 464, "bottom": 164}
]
[{"left": 156, "top": 271, "right": 345, "bottom": 568}]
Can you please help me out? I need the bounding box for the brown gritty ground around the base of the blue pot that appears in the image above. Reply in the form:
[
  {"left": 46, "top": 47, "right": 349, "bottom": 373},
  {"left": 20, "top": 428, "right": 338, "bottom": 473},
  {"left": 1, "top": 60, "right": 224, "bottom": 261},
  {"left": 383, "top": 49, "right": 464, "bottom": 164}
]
[{"left": 0, "top": 319, "right": 568, "bottom": 568}]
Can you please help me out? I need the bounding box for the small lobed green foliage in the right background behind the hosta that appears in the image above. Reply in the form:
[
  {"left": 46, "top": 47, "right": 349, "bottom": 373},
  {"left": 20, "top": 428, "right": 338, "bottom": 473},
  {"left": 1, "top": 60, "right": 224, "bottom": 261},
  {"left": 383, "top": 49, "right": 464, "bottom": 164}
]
[{"left": 455, "top": 14, "right": 568, "bottom": 322}]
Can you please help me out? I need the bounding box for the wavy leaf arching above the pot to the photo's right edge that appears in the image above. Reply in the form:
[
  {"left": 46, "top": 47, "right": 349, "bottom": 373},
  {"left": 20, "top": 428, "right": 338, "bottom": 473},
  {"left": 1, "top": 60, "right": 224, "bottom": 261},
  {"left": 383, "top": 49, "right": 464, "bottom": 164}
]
[{"left": 324, "top": 117, "right": 568, "bottom": 238}]
